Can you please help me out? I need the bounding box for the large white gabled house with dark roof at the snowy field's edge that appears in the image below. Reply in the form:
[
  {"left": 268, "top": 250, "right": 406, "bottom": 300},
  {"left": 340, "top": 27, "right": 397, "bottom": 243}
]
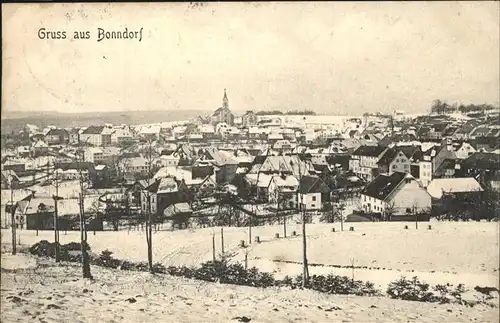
[{"left": 360, "top": 172, "right": 432, "bottom": 215}]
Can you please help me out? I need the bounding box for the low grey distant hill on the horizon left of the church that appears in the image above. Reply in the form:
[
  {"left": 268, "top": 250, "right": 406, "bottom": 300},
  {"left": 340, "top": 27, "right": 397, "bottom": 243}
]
[{"left": 1, "top": 110, "right": 210, "bottom": 133}]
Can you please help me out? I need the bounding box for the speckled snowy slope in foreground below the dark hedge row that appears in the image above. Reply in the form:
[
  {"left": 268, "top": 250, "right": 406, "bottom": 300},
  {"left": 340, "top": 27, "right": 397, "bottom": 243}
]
[{"left": 1, "top": 254, "right": 498, "bottom": 323}]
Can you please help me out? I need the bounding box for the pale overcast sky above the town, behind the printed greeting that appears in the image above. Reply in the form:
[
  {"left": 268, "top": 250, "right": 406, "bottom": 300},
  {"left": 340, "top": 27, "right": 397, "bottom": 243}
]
[{"left": 2, "top": 2, "right": 500, "bottom": 114}]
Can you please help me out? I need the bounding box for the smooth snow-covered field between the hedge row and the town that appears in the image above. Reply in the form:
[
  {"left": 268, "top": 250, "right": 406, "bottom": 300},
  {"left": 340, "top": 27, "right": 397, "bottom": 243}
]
[{"left": 2, "top": 222, "right": 499, "bottom": 289}]
